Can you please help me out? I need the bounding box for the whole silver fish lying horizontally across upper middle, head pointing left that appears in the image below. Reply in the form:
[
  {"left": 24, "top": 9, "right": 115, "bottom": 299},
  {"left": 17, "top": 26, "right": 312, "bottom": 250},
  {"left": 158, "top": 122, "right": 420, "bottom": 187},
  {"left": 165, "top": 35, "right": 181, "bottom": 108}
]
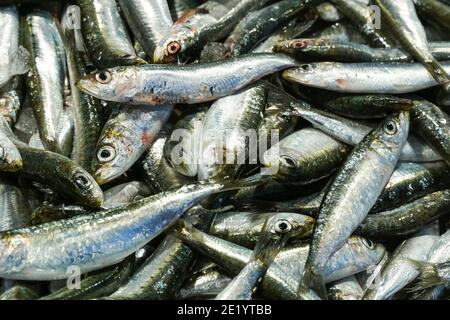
[{"left": 77, "top": 53, "right": 297, "bottom": 105}]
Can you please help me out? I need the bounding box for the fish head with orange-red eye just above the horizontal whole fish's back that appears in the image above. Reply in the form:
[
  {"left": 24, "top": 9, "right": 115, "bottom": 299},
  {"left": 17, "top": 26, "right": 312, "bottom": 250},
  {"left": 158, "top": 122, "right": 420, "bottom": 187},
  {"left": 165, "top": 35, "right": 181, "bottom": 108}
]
[{"left": 153, "top": 25, "right": 198, "bottom": 63}]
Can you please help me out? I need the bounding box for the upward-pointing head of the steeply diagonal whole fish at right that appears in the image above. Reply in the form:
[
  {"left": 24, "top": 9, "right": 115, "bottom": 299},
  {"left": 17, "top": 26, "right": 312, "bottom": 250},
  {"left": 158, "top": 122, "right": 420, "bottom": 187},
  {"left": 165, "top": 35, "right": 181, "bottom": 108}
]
[{"left": 375, "top": 111, "right": 410, "bottom": 151}]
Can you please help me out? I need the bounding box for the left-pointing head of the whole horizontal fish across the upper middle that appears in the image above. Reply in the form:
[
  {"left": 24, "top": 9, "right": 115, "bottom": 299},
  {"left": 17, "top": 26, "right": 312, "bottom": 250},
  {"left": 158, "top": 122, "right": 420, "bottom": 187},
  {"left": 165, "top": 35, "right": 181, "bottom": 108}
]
[{"left": 76, "top": 67, "right": 137, "bottom": 102}]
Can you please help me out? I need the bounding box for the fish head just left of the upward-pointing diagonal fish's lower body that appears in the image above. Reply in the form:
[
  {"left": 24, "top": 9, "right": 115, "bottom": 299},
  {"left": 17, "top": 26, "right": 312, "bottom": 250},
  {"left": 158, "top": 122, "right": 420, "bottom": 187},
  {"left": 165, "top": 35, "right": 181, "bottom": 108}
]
[{"left": 270, "top": 212, "right": 315, "bottom": 239}]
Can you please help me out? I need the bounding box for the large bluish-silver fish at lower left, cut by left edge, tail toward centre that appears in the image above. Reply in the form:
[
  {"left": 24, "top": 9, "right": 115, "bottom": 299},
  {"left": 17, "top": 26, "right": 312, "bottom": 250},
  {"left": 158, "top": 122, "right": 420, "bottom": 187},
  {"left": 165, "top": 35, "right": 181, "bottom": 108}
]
[{"left": 0, "top": 178, "right": 260, "bottom": 280}]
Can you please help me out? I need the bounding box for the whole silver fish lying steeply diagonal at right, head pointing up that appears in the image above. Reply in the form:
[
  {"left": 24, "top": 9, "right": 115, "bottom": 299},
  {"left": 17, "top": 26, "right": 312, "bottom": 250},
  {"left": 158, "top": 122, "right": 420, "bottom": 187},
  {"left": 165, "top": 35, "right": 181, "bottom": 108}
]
[{"left": 299, "top": 112, "right": 409, "bottom": 299}]
